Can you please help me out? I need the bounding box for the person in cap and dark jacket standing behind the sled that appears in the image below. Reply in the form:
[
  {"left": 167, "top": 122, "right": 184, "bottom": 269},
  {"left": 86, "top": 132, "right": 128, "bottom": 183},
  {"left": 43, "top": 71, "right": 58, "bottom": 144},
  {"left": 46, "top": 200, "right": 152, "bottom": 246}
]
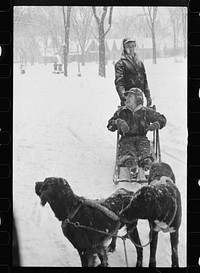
[{"left": 115, "top": 38, "right": 152, "bottom": 107}]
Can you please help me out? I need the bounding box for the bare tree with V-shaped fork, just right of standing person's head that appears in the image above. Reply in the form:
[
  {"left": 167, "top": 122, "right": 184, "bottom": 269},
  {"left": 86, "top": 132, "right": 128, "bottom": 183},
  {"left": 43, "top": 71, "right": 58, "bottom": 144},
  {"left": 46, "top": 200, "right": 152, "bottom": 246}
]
[{"left": 143, "top": 7, "right": 158, "bottom": 64}]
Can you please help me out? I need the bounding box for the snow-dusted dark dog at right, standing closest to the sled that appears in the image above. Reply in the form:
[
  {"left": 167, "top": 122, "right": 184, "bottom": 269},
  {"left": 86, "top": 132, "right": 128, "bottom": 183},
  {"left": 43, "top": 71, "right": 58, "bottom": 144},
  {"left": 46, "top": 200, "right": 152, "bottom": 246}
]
[{"left": 120, "top": 163, "right": 182, "bottom": 267}]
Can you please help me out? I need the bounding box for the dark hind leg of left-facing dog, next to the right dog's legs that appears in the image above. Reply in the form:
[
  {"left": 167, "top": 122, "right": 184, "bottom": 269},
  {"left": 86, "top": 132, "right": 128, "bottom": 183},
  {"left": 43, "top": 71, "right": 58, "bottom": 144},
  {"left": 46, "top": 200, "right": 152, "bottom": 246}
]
[{"left": 127, "top": 222, "right": 143, "bottom": 267}]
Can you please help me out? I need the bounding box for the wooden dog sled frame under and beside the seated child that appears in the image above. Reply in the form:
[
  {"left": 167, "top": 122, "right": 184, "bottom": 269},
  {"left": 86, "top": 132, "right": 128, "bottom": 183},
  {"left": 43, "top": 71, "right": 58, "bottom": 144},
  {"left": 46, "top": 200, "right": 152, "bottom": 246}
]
[{"left": 113, "top": 105, "right": 161, "bottom": 185}]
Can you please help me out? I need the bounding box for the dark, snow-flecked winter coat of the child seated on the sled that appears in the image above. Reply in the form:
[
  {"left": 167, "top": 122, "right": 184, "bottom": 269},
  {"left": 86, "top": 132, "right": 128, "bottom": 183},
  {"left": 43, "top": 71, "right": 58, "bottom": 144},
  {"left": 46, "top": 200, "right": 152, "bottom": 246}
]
[{"left": 107, "top": 106, "right": 167, "bottom": 137}]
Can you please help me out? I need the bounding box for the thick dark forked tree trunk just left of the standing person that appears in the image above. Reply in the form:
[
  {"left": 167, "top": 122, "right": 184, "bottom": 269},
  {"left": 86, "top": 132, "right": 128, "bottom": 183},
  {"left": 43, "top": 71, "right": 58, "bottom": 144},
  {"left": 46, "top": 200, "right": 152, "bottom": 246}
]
[{"left": 92, "top": 6, "right": 113, "bottom": 78}]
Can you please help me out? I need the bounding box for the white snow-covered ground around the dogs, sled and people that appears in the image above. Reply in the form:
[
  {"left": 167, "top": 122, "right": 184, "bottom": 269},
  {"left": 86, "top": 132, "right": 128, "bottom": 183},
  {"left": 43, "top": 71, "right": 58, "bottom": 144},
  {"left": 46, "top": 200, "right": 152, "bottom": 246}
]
[{"left": 13, "top": 56, "right": 187, "bottom": 267}]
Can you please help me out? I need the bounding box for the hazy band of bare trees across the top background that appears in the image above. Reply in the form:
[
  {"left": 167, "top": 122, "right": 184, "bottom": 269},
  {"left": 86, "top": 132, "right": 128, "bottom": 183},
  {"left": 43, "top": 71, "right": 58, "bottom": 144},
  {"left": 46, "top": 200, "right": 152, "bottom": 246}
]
[{"left": 14, "top": 6, "right": 187, "bottom": 77}]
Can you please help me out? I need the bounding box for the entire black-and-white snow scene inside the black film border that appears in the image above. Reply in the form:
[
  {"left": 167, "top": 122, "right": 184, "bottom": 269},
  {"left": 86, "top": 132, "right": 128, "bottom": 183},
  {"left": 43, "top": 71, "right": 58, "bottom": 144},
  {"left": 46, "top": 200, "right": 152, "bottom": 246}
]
[{"left": 13, "top": 5, "right": 188, "bottom": 268}]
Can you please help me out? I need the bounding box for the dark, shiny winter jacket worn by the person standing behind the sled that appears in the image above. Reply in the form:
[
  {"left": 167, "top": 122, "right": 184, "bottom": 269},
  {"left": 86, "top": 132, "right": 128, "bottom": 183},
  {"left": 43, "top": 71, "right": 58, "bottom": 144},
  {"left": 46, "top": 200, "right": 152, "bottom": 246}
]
[{"left": 115, "top": 52, "right": 150, "bottom": 101}]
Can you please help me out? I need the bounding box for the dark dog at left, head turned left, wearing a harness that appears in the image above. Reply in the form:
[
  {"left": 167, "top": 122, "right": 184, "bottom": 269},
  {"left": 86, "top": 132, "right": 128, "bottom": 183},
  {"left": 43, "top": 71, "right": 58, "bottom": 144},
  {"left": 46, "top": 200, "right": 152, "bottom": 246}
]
[{"left": 35, "top": 177, "right": 142, "bottom": 267}]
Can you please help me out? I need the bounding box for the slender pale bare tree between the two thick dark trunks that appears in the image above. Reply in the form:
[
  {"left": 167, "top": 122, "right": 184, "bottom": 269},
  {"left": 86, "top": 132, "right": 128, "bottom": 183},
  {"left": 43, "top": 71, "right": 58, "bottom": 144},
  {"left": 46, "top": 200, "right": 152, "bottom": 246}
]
[{"left": 72, "top": 7, "right": 92, "bottom": 65}]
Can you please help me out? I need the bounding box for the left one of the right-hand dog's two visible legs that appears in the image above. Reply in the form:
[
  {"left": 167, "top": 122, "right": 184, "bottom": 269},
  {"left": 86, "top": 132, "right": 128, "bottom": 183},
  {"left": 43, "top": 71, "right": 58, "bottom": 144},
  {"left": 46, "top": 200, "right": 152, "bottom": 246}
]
[{"left": 149, "top": 223, "right": 158, "bottom": 267}]
